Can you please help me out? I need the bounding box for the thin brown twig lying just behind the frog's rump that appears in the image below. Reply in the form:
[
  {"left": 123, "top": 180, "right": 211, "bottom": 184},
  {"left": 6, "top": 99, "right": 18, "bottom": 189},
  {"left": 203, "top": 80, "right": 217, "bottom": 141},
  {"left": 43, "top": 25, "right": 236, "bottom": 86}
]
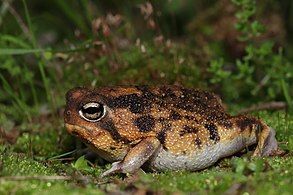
[{"left": 238, "top": 102, "right": 287, "bottom": 114}]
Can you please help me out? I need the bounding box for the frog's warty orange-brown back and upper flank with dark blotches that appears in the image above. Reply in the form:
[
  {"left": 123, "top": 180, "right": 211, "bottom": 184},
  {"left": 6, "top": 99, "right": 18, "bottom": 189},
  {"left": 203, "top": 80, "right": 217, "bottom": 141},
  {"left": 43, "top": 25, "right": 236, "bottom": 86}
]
[{"left": 99, "top": 86, "right": 231, "bottom": 155}]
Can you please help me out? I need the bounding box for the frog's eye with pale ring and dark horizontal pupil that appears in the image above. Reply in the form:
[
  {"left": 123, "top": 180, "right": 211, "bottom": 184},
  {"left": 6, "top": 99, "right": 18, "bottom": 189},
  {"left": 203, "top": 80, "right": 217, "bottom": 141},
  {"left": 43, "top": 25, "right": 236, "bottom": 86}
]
[{"left": 78, "top": 102, "right": 106, "bottom": 122}]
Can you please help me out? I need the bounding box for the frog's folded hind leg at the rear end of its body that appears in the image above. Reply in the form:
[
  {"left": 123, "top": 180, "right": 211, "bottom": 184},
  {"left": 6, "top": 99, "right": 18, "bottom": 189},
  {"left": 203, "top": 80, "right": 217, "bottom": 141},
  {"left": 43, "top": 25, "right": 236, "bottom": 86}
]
[{"left": 253, "top": 125, "right": 280, "bottom": 156}]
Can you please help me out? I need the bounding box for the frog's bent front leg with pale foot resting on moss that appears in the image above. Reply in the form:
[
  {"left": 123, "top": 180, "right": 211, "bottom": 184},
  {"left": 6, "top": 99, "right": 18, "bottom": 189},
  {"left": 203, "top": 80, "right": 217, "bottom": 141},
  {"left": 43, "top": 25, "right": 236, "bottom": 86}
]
[{"left": 101, "top": 137, "right": 160, "bottom": 177}]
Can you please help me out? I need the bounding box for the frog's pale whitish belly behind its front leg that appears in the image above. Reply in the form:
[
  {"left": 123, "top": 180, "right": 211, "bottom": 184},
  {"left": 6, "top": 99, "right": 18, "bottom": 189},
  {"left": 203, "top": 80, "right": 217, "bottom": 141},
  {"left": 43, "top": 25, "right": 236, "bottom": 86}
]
[{"left": 148, "top": 137, "right": 256, "bottom": 171}]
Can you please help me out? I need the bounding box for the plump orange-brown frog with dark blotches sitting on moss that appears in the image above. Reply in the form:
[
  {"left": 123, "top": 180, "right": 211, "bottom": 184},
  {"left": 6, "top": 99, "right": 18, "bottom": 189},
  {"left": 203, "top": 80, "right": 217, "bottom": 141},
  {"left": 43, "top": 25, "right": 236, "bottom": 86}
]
[{"left": 64, "top": 85, "right": 278, "bottom": 177}]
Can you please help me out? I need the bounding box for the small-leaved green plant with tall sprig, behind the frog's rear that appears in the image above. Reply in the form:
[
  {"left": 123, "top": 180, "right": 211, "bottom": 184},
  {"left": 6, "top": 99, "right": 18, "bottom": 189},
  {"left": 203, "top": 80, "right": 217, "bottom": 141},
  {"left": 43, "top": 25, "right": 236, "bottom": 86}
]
[{"left": 208, "top": 0, "right": 293, "bottom": 108}]
